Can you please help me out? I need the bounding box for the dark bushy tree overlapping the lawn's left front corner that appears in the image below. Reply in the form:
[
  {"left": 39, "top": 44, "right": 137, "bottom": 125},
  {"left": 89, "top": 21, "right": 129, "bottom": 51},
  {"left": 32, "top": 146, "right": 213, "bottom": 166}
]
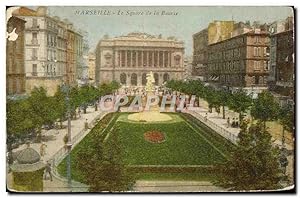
[{"left": 78, "top": 125, "right": 134, "bottom": 192}]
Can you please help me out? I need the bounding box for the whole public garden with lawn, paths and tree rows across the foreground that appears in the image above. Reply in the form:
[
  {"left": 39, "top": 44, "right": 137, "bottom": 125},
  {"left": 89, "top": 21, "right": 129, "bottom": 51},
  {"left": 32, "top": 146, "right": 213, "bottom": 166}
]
[{"left": 8, "top": 78, "right": 294, "bottom": 192}]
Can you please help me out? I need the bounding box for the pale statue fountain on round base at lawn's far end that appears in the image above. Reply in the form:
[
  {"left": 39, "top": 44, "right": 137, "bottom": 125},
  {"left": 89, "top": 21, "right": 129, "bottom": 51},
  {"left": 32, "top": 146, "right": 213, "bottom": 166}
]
[{"left": 128, "top": 71, "right": 172, "bottom": 122}]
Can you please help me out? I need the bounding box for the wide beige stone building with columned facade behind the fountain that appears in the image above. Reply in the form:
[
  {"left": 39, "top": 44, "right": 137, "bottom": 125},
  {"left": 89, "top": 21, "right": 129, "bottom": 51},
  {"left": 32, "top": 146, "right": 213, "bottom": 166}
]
[{"left": 95, "top": 33, "right": 185, "bottom": 87}]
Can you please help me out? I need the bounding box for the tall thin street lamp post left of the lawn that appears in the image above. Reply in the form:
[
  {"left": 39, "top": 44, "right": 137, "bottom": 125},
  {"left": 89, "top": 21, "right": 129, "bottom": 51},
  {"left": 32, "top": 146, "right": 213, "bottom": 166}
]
[{"left": 62, "top": 83, "right": 72, "bottom": 190}]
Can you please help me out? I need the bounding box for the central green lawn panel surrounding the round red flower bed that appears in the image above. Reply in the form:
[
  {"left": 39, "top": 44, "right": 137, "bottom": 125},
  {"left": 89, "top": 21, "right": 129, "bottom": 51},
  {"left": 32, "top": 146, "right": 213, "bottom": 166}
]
[{"left": 111, "top": 116, "right": 225, "bottom": 165}]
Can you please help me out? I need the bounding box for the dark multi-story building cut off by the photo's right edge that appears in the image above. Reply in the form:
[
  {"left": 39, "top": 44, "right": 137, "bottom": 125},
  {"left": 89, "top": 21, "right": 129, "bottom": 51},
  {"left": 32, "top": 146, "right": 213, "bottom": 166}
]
[{"left": 268, "top": 17, "right": 295, "bottom": 103}]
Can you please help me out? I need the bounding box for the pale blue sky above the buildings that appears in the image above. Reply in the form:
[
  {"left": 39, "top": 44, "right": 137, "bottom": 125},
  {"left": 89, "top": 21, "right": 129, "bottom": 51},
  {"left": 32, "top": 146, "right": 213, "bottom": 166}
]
[{"left": 48, "top": 6, "right": 293, "bottom": 55}]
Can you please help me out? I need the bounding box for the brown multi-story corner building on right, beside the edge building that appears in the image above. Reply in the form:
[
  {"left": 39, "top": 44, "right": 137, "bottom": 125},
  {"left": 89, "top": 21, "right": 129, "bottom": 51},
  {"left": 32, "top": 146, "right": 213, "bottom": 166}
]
[{"left": 207, "top": 31, "right": 269, "bottom": 90}]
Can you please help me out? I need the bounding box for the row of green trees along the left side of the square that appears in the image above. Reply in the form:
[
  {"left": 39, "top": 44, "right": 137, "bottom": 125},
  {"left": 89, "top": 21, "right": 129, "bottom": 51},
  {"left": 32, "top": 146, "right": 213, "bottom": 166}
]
[{"left": 7, "top": 81, "right": 119, "bottom": 142}]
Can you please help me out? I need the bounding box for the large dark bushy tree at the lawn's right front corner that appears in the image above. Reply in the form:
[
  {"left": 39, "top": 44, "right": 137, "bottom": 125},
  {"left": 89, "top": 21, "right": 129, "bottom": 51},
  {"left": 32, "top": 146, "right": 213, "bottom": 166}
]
[{"left": 215, "top": 122, "right": 283, "bottom": 190}]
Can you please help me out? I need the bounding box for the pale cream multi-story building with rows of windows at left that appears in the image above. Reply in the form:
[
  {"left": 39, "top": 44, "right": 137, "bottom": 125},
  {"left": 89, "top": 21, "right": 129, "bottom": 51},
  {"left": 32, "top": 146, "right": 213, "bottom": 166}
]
[{"left": 13, "top": 7, "right": 64, "bottom": 95}]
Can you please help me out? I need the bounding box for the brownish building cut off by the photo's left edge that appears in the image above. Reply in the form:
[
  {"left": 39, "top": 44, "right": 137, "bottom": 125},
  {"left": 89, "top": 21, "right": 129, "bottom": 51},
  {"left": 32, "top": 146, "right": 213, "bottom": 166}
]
[{"left": 6, "top": 16, "right": 26, "bottom": 95}]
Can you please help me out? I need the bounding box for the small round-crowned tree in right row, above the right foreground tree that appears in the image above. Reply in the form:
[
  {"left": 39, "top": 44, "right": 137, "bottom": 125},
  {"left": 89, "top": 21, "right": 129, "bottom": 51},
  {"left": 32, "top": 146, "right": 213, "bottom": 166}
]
[{"left": 251, "top": 91, "right": 280, "bottom": 127}]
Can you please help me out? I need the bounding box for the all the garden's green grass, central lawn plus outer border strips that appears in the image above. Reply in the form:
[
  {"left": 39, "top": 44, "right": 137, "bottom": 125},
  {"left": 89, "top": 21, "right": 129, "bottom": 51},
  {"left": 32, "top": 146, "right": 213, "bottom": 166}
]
[{"left": 58, "top": 113, "right": 232, "bottom": 183}]
